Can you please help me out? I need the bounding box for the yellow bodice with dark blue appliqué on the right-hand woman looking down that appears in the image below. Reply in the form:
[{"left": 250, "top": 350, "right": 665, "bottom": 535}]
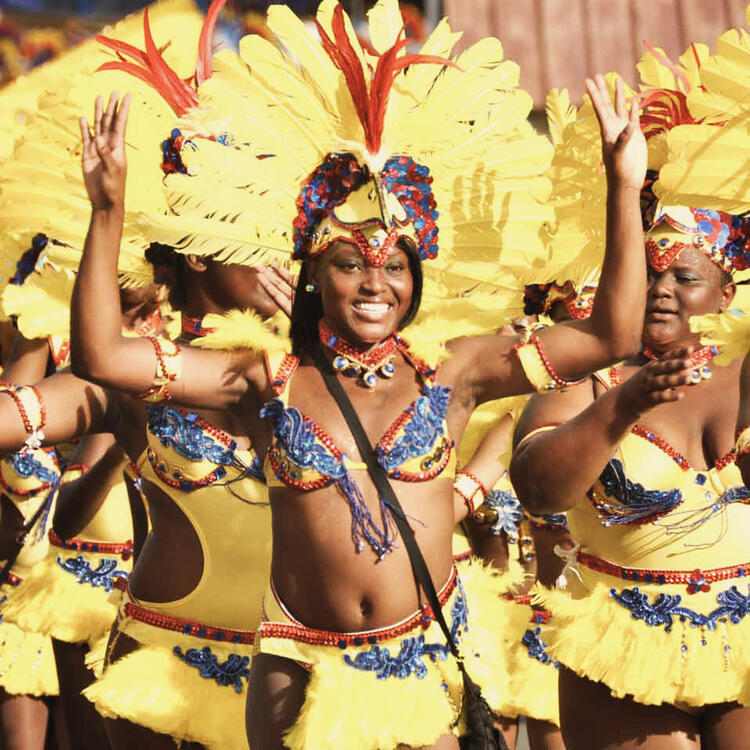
[{"left": 568, "top": 373, "right": 750, "bottom": 569}]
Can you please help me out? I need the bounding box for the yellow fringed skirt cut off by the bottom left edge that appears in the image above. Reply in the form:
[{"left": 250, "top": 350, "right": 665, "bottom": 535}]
[{"left": 0, "top": 576, "right": 60, "bottom": 697}]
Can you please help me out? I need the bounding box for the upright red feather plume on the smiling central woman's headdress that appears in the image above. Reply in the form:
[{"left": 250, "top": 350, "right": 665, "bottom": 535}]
[{"left": 315, "top": 5, "right": 458, "bottom": 154}]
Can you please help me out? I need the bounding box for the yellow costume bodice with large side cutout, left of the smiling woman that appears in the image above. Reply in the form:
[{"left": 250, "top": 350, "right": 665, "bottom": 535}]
[{"left": 140, "top": 402, "right": 271, "bottom": 630}]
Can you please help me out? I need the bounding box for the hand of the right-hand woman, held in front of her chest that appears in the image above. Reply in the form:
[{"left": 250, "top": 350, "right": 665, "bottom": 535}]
[{"left": 620, "top": 349, "right": 700, "bottom": 417}]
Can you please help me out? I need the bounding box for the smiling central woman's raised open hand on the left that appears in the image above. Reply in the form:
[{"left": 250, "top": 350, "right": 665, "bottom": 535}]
[{"left": 80, "top": 91, "right": 130, "bottom": 210}]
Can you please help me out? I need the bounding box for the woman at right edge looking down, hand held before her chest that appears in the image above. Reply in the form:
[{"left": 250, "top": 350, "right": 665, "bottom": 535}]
[{"left": 511, "top": 39, "right": 750, "bottom": 748}]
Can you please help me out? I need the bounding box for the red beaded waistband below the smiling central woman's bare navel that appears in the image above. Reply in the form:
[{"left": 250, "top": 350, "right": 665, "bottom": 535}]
[{"left": 258, "top": 568, "right": 458, "bottom": 648}]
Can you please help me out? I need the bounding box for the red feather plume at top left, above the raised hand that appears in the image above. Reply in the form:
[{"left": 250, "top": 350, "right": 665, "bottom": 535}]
[{"left": 96, "top": 0, "right": 227, "bottom": 115}]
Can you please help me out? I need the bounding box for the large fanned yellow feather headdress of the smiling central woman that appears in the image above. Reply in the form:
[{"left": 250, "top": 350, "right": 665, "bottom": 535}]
[{"left": 139, "top": 0, "right": 551, "bottom": 350}]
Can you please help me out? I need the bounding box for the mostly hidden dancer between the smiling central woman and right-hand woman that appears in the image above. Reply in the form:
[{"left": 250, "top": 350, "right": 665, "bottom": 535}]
[{"left": 454, "top": 394, "right": 564, "bottom": 750}]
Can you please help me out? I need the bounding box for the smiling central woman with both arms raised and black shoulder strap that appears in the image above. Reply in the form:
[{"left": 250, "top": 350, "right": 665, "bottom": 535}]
[{"left": 67, "top": 2, "right": 645, "bottom": 750}]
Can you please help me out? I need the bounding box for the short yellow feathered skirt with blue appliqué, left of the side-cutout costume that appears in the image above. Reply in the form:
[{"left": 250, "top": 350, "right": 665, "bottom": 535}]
[{"left": 3, "top": 543, "right": 132, "bottom": 647}]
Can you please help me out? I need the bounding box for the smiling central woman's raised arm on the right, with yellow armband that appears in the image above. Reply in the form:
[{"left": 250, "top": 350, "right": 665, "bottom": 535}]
[{"left": 452, "top": 76, "right": 647, "bottom": 403}]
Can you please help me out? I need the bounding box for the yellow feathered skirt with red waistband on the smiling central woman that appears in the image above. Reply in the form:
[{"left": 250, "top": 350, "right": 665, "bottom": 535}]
[{"left": 256, "top": 572, "right": 500, "bottom": 750}]
